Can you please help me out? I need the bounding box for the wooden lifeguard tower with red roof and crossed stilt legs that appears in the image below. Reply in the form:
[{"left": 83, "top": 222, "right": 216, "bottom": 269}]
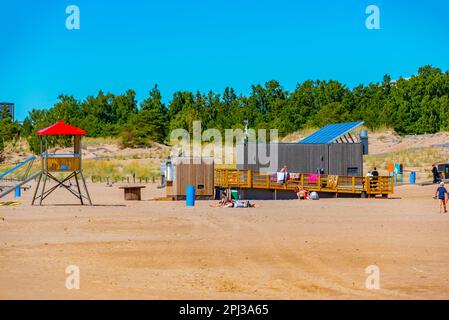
[{"left": 31, "top": 121, "right": 92, "bottom": 205}]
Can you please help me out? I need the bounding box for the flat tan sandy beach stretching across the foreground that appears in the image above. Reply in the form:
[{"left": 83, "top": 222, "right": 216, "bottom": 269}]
[{"left": 0, "top": 184, "right": 449, "bottom": 299}]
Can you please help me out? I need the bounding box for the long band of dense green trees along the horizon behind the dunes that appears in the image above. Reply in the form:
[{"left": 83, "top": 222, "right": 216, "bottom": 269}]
[{"left": 13, "top": 65, "right": 449, "bottom": 150}]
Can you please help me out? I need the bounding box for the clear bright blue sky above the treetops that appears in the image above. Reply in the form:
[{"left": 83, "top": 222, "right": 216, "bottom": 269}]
[{"left": 0, "top": 0, "right": 449, "bottom": 120}]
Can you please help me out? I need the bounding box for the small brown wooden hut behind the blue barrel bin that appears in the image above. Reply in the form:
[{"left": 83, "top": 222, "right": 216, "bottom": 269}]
[{"left": 165, "top": 158, "right": 214, "bottom": 200}]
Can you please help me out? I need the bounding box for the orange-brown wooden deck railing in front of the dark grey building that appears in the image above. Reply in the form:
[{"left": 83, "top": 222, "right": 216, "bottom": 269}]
[{"left": 214, "top": 169, "right": 394, "bottom": 197}]
